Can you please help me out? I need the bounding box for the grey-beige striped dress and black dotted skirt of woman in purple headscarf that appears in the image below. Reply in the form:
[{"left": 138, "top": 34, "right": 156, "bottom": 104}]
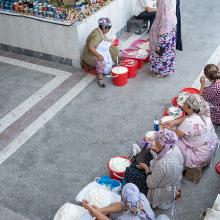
[{"left": 125, "top": 146, "right": 184, "bottom": 208}]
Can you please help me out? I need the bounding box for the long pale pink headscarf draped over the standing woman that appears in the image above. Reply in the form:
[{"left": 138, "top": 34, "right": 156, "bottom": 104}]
[{"left": 150, "top": 0, "right": 177, "bottom": 51}]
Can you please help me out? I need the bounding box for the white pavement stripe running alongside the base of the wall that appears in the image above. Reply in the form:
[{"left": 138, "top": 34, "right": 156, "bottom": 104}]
[{"left": 0, "top": 56, "right": 70, "bottom": 76}]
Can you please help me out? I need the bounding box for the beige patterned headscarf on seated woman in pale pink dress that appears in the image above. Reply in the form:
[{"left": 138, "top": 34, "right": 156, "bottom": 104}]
[{"left": 185, "top": 94, "right": 210, "bottom": 121}]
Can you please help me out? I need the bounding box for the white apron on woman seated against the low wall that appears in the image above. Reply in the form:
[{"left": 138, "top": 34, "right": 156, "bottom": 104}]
[{"left": 96, "top": 40, "right": 113, "bottom": 75}]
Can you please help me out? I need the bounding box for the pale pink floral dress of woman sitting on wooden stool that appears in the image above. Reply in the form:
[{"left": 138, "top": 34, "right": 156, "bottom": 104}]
[{"left": 177, "top": 114, "right": 218, "bottom": 168}]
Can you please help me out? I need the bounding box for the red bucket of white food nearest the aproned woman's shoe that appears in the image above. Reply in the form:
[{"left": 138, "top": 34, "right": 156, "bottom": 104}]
[{"left": 112, "top": 66, "right": 128, "bottom": 86}]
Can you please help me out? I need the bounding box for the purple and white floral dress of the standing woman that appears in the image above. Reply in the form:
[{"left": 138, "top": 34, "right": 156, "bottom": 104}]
[{"left": 150, "top": 31, "right": 176, "bottom": 76}]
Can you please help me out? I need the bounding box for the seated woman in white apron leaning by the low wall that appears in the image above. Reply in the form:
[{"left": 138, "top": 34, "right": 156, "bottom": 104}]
[{"left": 82, "top": 18, "right": 117, "bottom": 88}]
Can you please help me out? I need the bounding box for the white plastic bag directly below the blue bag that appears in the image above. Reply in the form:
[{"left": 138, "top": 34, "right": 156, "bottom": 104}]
[{"left": 75, "top": 181, "right": 121, "bottom": 208}]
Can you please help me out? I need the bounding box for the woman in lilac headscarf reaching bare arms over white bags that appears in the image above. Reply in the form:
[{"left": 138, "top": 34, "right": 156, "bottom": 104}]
[{"left": 83, "top": 183, "right": 169, "bottom": 220}]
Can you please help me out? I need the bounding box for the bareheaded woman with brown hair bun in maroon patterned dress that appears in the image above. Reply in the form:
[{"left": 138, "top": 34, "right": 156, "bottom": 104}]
[{"left": 200, "top": 64, "right": 220, "bottom": 125}]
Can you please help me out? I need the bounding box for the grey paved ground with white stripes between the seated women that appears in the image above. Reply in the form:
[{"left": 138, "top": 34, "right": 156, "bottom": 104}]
[{"left": 0, "top": 0, "right": 220, "bottom": 220}]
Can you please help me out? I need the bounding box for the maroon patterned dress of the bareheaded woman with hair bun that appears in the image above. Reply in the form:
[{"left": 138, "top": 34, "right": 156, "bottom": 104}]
[{"left": 202, "top": 82, "right": 220, "bottom": 125}]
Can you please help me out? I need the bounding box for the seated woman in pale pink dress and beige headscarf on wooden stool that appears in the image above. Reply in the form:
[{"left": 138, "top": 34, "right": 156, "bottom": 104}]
[{"left": 164, "top": 94, "right": 218, "bottom": 179}]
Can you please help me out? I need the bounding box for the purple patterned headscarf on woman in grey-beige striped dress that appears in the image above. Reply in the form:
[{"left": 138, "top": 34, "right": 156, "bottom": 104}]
[{"left": 155, "top": 128, "right": 178, "bottom": 159}]
